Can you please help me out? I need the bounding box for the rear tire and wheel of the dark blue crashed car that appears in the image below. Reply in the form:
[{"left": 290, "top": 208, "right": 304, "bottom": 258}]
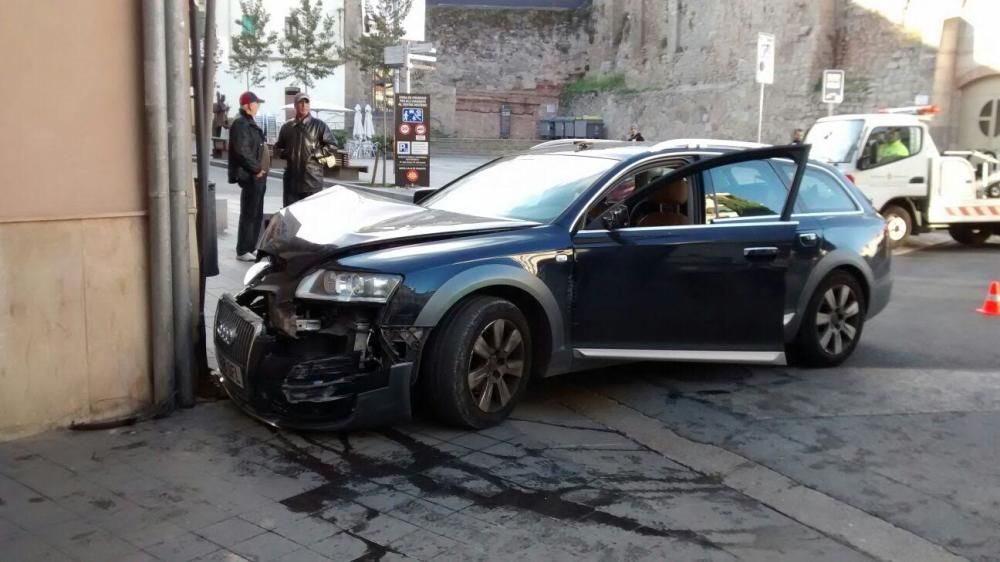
[{"left": 795, "top": 271, "right": 867, "bottom": 367}]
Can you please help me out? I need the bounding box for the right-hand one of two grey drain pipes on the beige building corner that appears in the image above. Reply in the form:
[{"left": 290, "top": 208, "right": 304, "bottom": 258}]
[{"left": 164, "top": 0, "right": 194, "bottom": 407}]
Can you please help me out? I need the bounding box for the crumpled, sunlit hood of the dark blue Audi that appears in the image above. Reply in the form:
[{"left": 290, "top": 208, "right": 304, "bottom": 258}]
[{"left": 259, "top": 185, "right": 536, "bottom": 262}]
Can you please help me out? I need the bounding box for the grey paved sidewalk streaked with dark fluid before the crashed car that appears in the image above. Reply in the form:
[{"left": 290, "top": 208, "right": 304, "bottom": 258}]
[{"left": 0, "top": 380, "right": 866, "bottom": 562}]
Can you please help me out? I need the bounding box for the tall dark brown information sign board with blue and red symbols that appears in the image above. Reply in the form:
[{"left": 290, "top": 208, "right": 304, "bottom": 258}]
[{"left": 393, "top": 93, "right": 431, "bottom": 187}]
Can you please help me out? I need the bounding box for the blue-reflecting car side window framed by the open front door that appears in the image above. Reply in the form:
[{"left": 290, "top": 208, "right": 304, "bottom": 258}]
[{"left": 703, "top": 160, "right": 788, "bottom": 224}]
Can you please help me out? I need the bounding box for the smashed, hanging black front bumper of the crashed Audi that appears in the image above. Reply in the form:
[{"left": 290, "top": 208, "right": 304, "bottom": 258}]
[{"left": 215, "top": 295, "right": 413, "bottom": 431}]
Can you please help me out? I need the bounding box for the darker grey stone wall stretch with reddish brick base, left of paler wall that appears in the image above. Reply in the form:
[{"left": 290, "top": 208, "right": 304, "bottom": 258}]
[{"left": 413, "top": 6, "right": 590, "bottom": 138}]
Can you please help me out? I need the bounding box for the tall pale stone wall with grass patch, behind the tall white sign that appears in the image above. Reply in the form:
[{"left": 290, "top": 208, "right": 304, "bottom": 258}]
[{"left": 568, "top": 0, "right": 835, "bottom": 142}]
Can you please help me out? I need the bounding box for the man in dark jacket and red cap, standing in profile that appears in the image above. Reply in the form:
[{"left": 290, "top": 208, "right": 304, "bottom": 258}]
[{"left": 229, "top": 92, "right": 271, "bottom": 261}]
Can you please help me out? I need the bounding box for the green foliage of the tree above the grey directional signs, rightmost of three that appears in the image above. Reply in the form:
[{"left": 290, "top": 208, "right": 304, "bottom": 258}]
[{"left": 340, "top": 0, "right": 413, "bottom": 76}]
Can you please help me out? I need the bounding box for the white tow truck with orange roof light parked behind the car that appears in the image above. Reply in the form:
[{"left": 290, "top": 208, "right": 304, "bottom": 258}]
[{"left": 805, "top": 106, "right": 1000, "bottom": 246}]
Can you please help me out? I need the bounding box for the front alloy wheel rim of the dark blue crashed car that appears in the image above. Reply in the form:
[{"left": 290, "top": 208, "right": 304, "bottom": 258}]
[{"left": 468, "top": 319, "right": 524, "bottom": 412}]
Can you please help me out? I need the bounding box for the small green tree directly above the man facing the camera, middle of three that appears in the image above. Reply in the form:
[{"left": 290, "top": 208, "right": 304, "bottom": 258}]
[{"left": 275, "top": 0, "right": 341, "bottom": 91}]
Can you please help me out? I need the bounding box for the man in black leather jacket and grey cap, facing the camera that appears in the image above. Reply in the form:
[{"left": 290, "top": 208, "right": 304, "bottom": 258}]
[{"left": 274, "top": 93, "right": 339, "bottom": 207}]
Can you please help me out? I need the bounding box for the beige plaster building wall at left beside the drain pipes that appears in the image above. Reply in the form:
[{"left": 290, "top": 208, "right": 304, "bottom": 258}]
[{"left": 0, "top": 0, "right": 150, "bottom": 439}]
